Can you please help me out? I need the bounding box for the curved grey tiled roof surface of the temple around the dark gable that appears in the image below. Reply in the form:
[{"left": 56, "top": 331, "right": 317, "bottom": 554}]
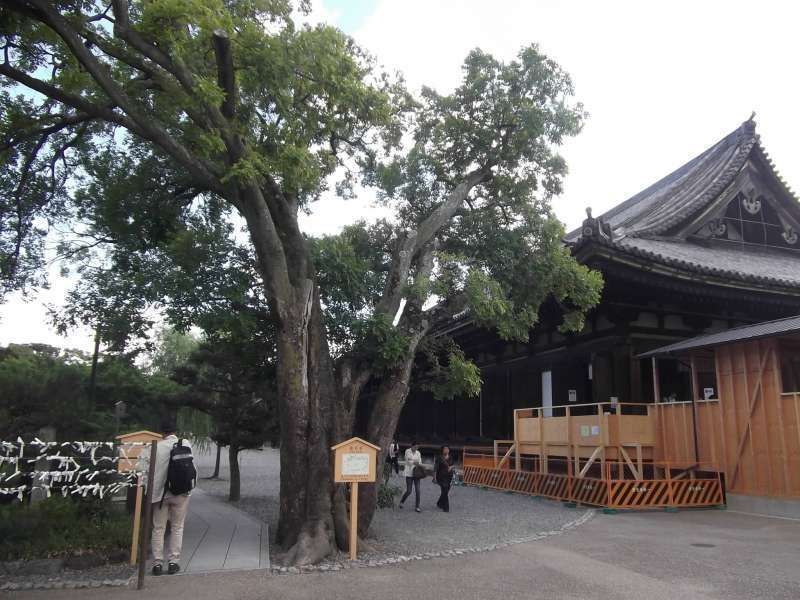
[{"left": 565, "top": 119, "right": 800, "bottom": 289}]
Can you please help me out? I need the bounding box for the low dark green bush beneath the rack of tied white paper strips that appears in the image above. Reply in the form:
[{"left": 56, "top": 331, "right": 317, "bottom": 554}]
[{"left": 0, "top": 496, "right": 131, "bottom": 560}]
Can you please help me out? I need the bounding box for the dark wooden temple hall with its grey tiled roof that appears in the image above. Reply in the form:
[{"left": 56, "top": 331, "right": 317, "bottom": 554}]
[{"left": 398, "top": 119, "right": 800, "bottom": 444}]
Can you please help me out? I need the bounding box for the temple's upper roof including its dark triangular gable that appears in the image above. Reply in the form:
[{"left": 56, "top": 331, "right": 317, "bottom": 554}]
[{"left": 565, "top": 117, "right": 800, "bottom": 289}]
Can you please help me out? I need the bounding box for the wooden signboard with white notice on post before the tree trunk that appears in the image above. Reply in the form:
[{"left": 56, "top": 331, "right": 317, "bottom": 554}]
[{"left": 331, "top": 438, "right": 380, "bottom": 560}]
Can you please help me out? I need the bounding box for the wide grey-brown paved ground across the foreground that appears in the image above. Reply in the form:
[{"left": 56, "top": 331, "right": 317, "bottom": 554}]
[{"left": 13, "top": 511, "right": 800, "bottom": 600}]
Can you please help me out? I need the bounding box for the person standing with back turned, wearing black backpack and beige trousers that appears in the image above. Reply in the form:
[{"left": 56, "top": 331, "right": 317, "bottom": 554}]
[{"left": 151, "top": 420, "right": 197, "bottom": 575}]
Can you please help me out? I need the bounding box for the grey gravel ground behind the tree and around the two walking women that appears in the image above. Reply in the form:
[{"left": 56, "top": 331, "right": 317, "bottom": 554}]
[{"left": 196, "top": 442, "right": 584, "bottom": 559}]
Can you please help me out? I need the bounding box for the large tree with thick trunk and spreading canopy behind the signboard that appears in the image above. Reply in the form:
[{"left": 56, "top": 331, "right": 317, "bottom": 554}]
[{"left": 0, "top": 0, "right": 601, "bottom": 563}]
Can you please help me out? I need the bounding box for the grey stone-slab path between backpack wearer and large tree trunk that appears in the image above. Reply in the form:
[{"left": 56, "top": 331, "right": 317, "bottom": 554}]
[{"left": 174, "top": 489, "right": 269, "bottom": 573}]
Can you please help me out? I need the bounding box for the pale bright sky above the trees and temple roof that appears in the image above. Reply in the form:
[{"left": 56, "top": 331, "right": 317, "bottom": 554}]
[{"left": 0, "top": 0, "right": 800, "bottom": 350}]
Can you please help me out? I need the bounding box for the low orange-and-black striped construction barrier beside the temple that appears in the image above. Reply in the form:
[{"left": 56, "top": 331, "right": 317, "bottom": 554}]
[{"left": 464, "top": 464, "right": 724, "bottom": 509}]
